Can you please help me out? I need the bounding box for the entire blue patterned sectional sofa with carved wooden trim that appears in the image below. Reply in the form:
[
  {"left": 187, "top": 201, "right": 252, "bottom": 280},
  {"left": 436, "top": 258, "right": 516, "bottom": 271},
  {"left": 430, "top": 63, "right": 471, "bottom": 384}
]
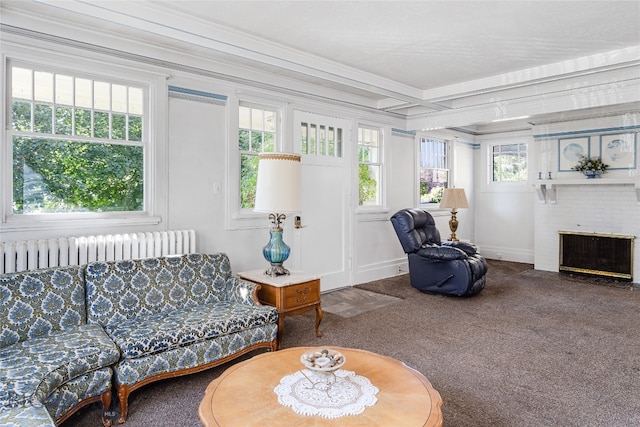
[{"left": 0, "top": 254, "right": 278, "bottom": 427}]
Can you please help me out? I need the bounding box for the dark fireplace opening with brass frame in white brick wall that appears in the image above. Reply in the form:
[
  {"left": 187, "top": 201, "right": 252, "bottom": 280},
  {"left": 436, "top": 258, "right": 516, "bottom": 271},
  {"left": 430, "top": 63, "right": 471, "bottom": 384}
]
[{"left": 558, "top": 231, "right": 634, "bottom": 281}]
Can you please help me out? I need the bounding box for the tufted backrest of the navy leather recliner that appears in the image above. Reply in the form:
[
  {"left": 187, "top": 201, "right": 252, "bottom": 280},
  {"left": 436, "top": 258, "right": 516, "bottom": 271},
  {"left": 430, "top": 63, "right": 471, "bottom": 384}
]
[{"left": 391, "top": 208, "right": 441, "bottom": 254}]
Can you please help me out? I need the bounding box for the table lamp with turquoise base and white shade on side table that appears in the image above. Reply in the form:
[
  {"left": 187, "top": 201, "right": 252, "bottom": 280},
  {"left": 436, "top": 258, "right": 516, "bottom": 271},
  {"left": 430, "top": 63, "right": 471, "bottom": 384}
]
[{"left": 253, "top": 153, "right": 300, "bottom": 277}]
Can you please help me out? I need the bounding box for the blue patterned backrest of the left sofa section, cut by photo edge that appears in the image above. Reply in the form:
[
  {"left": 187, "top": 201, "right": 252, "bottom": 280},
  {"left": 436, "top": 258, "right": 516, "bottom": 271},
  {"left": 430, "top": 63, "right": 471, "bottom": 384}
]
[{"left": 0, "top": 266, "right": 87, "bottom": 347}]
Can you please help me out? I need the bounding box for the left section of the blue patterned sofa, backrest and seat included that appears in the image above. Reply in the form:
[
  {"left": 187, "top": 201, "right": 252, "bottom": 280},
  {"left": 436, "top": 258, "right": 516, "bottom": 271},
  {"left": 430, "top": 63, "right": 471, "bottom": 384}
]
[{"left": 0, "top": 267, "right": 120, "bottom": 426}]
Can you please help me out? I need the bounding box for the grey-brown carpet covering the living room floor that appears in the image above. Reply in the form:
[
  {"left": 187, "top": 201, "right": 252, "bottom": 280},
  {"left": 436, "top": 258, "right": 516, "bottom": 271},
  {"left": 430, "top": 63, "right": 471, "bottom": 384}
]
[{"left": 63, "top": 261, "right": 640, "bottom": 427}]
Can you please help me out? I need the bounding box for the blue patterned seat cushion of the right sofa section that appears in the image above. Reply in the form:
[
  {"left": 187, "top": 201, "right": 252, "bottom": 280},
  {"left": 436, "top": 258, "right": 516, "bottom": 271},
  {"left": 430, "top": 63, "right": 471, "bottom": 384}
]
[{"left": 105, "top": 301, "right": 278, "bottom": 359}]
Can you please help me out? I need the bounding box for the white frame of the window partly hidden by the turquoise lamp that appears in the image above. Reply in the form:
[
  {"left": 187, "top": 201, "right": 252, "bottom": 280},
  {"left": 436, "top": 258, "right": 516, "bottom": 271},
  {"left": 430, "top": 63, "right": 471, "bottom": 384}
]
[{"left": 227, "top": 94, "right": 287, "bottom": 230}]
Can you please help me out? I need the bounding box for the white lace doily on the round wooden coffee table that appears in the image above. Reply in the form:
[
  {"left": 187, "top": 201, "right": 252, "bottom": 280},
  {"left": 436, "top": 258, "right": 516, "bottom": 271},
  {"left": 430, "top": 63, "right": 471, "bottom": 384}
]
[{"left": 274, "top": 369, "right": 378, "bottom": 418}]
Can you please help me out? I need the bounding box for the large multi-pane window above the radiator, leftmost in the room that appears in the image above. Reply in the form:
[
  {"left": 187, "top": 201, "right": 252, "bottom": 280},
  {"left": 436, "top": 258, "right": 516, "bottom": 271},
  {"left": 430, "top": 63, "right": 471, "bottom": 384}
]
[{"left": 7, "top": 64, "right": 148, "bottom": 215}]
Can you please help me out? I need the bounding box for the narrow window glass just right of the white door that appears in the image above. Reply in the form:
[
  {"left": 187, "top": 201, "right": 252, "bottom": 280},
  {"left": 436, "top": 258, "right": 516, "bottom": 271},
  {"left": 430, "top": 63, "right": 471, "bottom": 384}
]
[{"left": 358, "top": 126, "right": 382, "bottom": 206}]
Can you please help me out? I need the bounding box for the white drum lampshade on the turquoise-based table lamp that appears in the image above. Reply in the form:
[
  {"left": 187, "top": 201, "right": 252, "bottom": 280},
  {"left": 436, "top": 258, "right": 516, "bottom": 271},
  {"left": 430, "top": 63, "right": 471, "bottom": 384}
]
[{"left": 253, "top": 153, "right": 300, "bottom": 213}]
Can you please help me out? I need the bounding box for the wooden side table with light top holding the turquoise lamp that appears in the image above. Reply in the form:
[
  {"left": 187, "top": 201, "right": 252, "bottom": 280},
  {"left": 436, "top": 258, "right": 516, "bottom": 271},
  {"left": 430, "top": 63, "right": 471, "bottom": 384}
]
[{"left": 238, "top": 270, "right": 323, "bottom": 349}]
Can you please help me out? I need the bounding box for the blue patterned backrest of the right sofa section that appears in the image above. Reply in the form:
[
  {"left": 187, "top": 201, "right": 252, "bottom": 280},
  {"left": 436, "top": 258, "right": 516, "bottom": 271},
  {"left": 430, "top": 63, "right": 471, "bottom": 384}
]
[{"left": 86, "top": 254, "right": 231, "bottom": 326}]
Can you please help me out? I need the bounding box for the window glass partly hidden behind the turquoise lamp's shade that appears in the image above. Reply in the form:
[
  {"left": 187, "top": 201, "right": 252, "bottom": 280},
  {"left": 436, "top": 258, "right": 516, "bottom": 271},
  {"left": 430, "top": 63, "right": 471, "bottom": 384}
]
[{"left": 238, "top": 102, "right": 278, "bottom": 209}]
